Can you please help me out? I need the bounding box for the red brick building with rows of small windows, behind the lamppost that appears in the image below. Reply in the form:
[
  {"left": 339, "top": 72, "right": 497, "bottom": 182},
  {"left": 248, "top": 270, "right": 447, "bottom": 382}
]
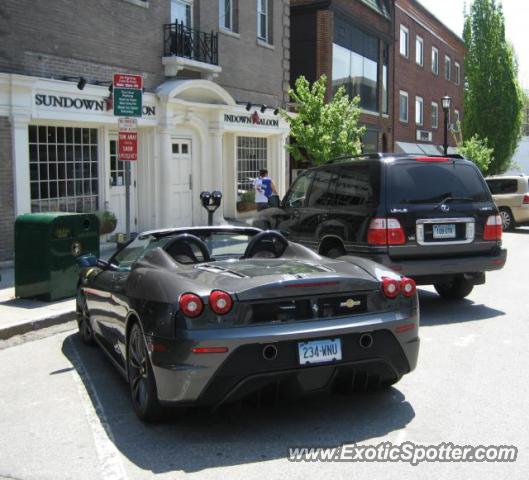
[{"left": 391, "top": 0, "right": 465, "bottom": 154}]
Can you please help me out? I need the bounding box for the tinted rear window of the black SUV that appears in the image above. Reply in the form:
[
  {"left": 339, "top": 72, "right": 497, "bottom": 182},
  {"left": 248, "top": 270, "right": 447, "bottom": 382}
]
[{"left": 388, "top": 162, "right": 491, "bottom": 205}]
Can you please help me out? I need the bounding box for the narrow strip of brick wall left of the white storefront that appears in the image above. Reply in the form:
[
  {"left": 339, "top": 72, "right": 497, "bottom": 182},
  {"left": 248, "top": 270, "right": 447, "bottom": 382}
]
[{"left": 0, "top": 117, "right": 15, "bottom": 261}]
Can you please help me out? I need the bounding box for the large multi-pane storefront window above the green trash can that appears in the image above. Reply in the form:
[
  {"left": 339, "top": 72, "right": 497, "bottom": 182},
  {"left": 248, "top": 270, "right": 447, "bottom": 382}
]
[{"left": 28, "top": 125, "right": 99, "bottom": 212}]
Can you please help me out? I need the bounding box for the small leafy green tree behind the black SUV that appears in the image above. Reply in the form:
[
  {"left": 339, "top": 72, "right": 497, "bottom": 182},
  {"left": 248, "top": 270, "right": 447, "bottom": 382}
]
[{"left": 280, "top": 75, "right": 365, "bottom": 165}]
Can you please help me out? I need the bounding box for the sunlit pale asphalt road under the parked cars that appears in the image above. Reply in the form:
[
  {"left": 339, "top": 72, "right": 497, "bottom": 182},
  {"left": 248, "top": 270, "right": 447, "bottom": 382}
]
[{"left": 0, "top": 230, "right": 529, "bottom": 480}]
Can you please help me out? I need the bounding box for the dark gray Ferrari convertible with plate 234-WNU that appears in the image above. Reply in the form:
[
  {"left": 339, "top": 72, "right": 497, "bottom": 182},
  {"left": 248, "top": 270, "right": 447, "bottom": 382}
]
[{"left": 77, "top": 227, "right": 419, "bottom": 420}]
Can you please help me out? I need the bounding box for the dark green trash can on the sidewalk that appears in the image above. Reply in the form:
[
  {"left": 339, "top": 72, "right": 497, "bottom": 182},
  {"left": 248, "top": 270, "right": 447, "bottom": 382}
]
[{"left": 15, "top": 212, "right": 99, "bottom": 301}]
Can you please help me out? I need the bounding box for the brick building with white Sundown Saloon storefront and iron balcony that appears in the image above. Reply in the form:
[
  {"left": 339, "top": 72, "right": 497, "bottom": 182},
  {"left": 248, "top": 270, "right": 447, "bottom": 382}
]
[{"left": 0, "top": 0, "right": 290, "bottom": 261}]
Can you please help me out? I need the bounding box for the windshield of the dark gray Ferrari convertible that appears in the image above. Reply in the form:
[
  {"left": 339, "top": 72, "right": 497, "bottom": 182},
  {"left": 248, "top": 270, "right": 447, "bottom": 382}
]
[{"left": 111, "top": 230, "right": 251, "bottom": 270}]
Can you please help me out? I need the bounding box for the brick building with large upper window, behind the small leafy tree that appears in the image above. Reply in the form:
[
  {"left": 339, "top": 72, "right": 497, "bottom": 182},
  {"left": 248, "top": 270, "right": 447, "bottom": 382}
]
[{"left": 290, "top": 0, "right": 393, "bottom": 163}]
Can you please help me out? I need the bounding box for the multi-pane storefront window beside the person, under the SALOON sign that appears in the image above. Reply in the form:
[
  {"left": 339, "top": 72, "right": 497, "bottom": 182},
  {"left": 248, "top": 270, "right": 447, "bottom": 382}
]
[{"left": 237, "top": 137, "right": 268, "bottom": 212}]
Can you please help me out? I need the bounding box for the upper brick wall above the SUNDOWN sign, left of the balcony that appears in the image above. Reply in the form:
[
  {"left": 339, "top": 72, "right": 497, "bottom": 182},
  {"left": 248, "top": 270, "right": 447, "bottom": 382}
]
[{"left": 0, "top": 0, "right": 170, "bottom": 89}]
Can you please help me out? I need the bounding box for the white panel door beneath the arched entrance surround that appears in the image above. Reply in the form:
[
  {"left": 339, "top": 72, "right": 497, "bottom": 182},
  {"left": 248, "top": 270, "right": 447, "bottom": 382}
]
[{"left": 168, "top": 139, "right": 193, "bottom": 227}]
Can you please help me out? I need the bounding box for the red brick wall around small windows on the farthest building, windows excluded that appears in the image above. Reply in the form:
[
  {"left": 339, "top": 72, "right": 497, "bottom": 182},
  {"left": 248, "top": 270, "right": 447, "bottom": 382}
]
[{"left": 393, "top": 0, "right": 465, "bottom": 146}]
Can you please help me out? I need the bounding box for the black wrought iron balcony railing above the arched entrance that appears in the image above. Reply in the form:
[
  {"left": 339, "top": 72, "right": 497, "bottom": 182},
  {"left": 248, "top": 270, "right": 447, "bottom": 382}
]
[{"left": 164, "top": 22, "right": 219, "bottom": 65}]
